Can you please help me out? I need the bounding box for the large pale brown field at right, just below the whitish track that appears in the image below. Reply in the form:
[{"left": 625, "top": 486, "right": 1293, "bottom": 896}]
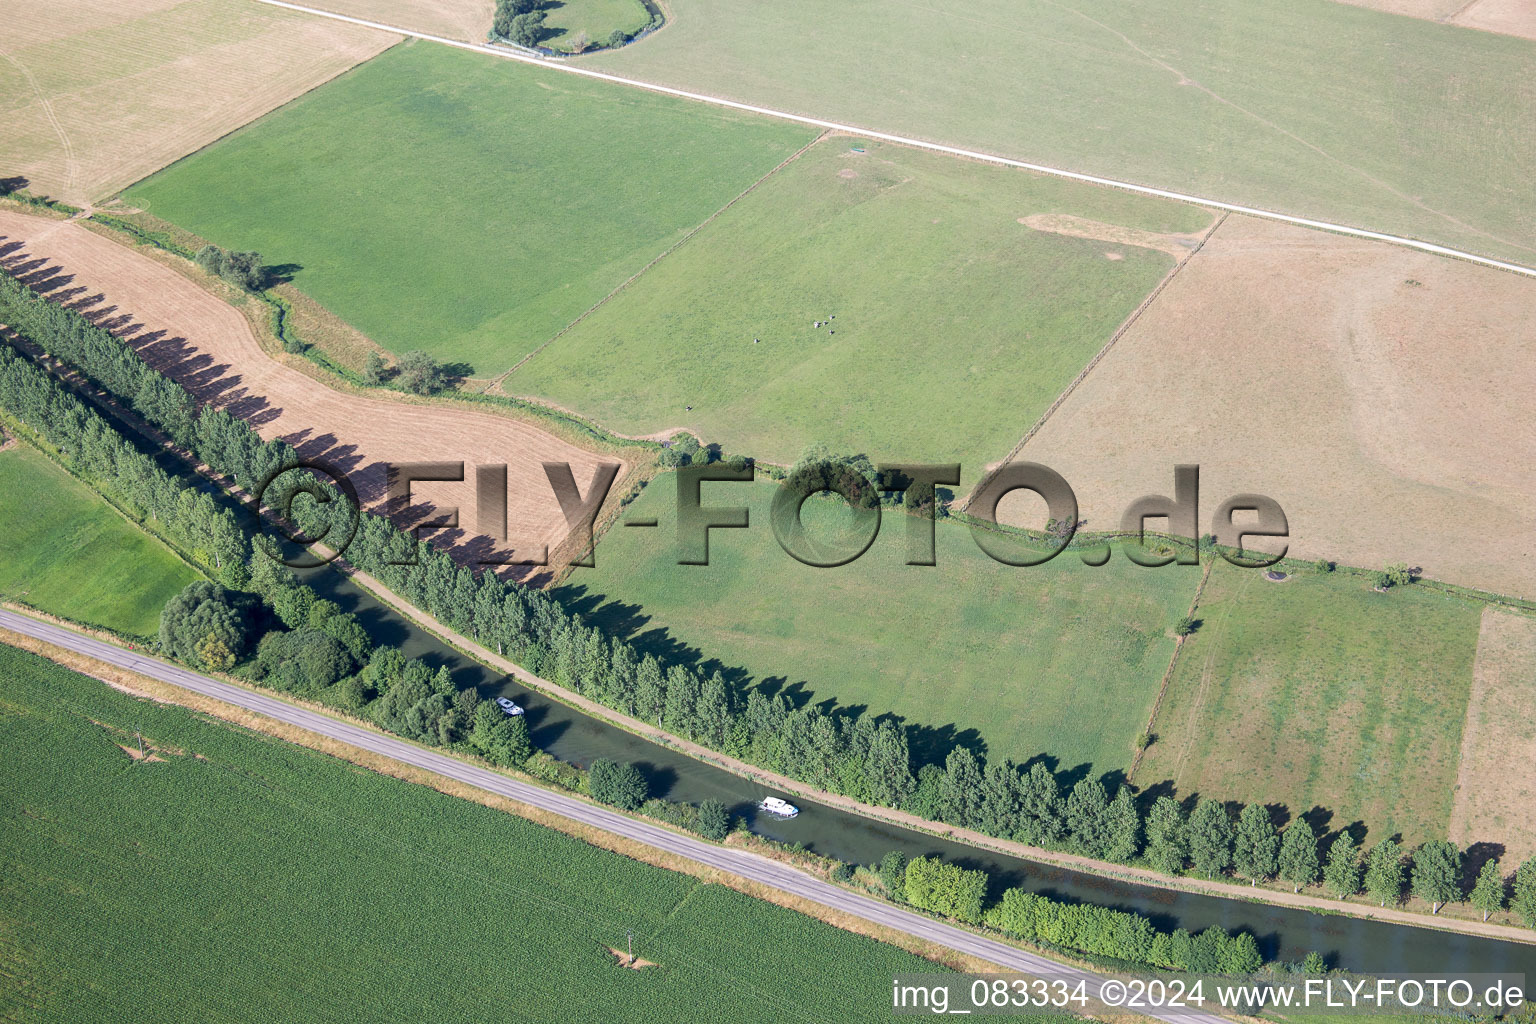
[{"left": 1018, "top": 216, "right": 1536, "bottom": 597}]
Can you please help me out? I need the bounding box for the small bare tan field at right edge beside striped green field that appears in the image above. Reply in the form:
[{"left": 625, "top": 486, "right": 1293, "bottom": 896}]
[{"left": 1450, "top": 608, "right": 1536, "bottom": 863}]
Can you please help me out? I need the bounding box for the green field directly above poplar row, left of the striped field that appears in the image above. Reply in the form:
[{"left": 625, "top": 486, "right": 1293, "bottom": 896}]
[{"left": 564, "top": 477, "right": 1200, "bottom": 771}]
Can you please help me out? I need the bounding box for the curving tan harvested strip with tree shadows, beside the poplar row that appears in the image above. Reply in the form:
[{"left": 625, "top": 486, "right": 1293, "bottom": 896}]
[{"left": 0, "top": 210, "right": 619, "bottom": 568}]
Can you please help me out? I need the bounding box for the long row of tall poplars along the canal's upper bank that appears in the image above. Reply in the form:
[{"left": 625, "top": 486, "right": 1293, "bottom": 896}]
[{"left": 0, "top": 262, "right": 1536, "bottom": 926}]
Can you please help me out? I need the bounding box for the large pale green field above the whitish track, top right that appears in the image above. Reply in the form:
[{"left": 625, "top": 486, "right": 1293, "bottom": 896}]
[{"left": 591, "top": 0, "right": 1536, "bottom": 264}]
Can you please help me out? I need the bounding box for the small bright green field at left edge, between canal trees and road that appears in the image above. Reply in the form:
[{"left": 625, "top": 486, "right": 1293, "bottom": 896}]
[{"left": 0, "top": 445, "right": 201, "bottom": 636}]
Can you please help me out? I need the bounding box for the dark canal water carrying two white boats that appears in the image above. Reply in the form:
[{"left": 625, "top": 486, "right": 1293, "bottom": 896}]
[{"left": 301, "top": 570, "right": 1536, "bottom": 979}]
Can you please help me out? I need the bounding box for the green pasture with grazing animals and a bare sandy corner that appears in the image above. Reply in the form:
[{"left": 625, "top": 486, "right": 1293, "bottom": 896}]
[{"left": 502, "top": 137, "right": 1210, "bottom": 473}]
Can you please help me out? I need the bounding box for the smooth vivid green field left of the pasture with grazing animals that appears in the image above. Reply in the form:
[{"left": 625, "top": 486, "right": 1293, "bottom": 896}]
[{"left": 126, "top": 43, "right": 813, "bottom": 376}]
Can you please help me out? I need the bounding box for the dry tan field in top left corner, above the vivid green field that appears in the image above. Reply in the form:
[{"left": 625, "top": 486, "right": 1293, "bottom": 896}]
[{"left": 0, "top": 0, "right": 396, "bottom": 203}]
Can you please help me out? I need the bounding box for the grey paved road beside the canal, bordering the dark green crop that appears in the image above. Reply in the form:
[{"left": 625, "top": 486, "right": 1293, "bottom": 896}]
[{"left": 0, "top": 609, "right": 1226, "bottom": 1024}]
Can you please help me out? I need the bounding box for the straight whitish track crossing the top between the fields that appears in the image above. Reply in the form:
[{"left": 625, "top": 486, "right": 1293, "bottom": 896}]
[{"left": 245, "top": 0, "right": 1536, "bottom": 278}]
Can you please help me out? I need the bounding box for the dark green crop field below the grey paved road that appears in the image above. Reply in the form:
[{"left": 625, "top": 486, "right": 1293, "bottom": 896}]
[{"left": 0, "top": 646, "right": 964, "bottom": 1022}]
